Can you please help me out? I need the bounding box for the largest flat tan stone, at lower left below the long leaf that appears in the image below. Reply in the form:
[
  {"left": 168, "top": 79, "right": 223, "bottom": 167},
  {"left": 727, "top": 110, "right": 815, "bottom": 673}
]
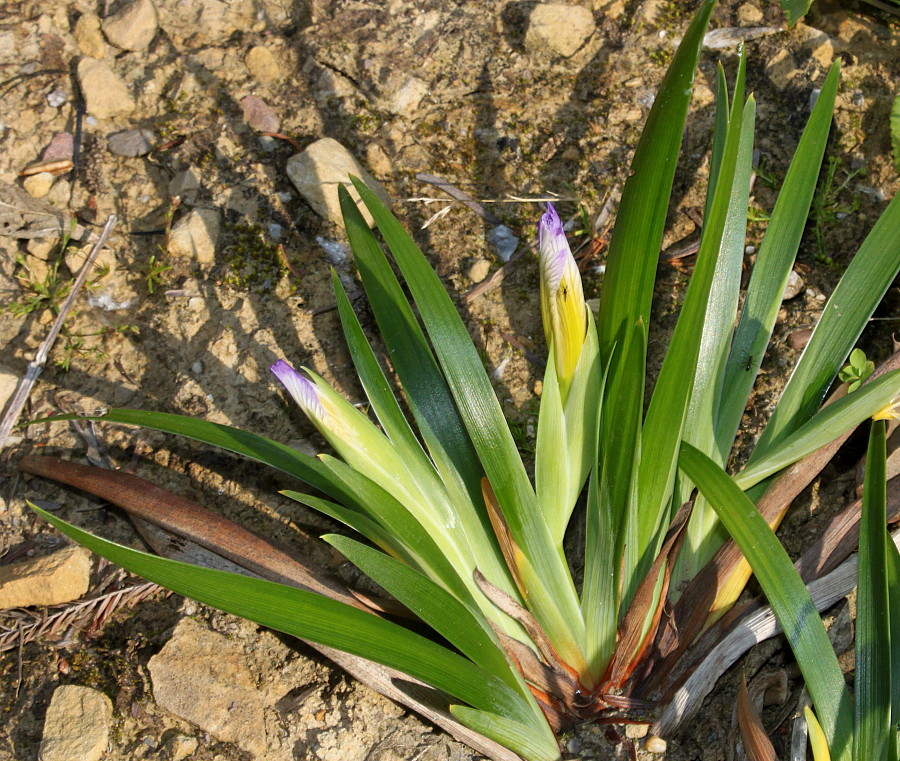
[{"left": 148, "top": 618, "right": 267, "bottom": 758}]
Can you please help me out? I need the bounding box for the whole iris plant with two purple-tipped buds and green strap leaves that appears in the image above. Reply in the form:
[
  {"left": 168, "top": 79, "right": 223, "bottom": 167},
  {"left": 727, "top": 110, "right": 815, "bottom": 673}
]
[{"left": 21, "top": 0, "right": 900, "bottom": 761}]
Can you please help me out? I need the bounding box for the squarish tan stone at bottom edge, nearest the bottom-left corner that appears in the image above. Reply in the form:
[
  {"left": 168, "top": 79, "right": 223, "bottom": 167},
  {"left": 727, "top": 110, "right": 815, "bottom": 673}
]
[{"left": 38, "top": 684, "right": 112, "bottom": 761}]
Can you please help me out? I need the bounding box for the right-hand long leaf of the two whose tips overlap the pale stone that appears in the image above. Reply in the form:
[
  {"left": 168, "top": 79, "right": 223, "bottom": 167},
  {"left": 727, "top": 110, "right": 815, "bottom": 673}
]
[{"left": 353, "top": 178, "right": 585, "bottom": 672}]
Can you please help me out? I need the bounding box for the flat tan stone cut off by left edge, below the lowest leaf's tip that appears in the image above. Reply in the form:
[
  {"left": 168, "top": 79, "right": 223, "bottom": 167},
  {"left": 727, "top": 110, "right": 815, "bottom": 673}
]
[{"left": 0, "top": 547, "right": 91, "bottom": 610}]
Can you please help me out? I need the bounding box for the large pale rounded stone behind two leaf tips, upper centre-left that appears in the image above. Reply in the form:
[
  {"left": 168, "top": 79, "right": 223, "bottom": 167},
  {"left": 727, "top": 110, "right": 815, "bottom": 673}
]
[{"left": 287, "top": 137, "right": 390, "bottom": 226}]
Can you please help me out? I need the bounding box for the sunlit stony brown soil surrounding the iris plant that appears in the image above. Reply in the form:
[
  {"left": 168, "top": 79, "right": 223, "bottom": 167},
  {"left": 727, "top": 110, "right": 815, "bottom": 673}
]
[{"left": 0, "top": 0, "right": 900, "bottom": 761}]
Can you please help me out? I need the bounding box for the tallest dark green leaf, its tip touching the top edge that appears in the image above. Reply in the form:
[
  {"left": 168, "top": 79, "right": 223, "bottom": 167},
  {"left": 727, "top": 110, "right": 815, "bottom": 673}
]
[{"left": 597, "top": 0, "right": 716, "bottom": 365}]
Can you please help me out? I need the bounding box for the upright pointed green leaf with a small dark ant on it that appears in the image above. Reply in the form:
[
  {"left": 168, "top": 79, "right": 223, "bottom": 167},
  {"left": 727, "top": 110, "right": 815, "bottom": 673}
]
[{"left": 716, "top": 63, "right": 840, "bottom": 454}]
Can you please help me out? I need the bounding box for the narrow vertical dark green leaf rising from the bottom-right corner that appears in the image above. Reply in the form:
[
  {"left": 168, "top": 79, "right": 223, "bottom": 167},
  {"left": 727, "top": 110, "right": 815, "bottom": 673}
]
[{"left": 854, "top": 420, "right": 891, "bottom": 759}]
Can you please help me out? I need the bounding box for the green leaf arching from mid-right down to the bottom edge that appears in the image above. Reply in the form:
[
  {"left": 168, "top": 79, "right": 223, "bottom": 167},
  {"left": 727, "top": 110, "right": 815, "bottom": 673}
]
[{"left": 678, "top": 444, "right": 853, "bottom": 761}]
